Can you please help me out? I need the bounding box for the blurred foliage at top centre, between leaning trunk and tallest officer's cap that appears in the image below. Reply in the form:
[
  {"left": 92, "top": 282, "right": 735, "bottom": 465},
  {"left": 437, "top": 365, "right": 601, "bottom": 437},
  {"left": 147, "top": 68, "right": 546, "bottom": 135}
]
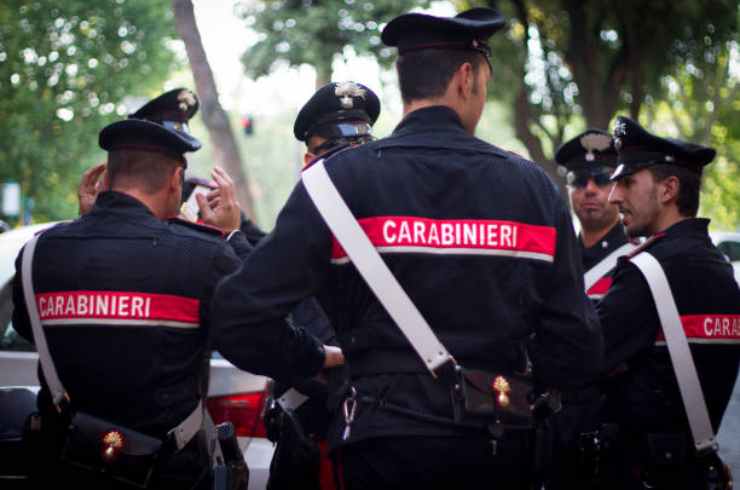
[{"left": 235, "top": 0, "right": 430, "bottom": 88}]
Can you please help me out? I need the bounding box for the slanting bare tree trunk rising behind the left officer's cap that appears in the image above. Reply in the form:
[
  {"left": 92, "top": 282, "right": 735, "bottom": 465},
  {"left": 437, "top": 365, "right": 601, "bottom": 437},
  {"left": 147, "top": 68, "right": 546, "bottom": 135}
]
[{"left": 172, "top": 0, "right": 254, "bottom": 220}]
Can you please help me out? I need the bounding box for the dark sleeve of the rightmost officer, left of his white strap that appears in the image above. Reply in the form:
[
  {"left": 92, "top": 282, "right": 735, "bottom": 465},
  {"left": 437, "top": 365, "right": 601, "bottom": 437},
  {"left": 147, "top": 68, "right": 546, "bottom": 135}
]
[{"left": 596, "top": 258, "right": 660, "bottom": 374}]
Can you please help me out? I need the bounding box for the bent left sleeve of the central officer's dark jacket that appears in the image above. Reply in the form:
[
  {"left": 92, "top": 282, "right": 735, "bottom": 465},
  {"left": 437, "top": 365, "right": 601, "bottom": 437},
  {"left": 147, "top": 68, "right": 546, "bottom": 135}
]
[{"left": 212, "top": 182, "right": 331, "bottom": 383}]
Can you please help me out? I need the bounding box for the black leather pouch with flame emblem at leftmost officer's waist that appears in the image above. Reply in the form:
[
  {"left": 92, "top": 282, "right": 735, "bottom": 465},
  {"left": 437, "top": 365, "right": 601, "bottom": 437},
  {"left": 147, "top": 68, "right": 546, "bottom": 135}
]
[{"left": 61, "top": 412, "right": 162, "bottom": 488}]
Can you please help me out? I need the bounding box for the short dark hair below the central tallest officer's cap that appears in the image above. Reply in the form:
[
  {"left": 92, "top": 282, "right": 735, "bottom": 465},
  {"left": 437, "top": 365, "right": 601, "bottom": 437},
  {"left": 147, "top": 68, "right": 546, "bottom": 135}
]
[{"left": 396, "top": 49, "right": 485, "bottom": 104}]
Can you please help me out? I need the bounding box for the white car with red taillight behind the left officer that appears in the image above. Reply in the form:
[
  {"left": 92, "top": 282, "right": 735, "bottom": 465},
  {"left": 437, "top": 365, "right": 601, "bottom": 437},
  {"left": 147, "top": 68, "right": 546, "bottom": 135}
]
[{"left": 0, "top": 223, "right": 274, "bottom": 490}]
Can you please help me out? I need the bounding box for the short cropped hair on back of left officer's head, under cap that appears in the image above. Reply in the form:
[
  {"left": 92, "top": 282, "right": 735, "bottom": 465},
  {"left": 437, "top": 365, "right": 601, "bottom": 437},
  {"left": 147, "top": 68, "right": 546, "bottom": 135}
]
[{"left": 108, "top": 149, "right": 182, "bottom": 194}]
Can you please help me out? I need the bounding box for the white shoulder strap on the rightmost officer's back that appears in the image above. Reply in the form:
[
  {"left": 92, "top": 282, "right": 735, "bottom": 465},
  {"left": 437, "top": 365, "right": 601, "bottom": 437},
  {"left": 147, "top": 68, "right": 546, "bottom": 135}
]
[{"left": 630, "top": 252, "right": 717, "bottom": 451}]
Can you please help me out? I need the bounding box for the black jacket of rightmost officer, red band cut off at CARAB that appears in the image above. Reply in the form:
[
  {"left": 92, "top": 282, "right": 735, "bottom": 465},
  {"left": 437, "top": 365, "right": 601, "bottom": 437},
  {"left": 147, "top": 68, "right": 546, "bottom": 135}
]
[{"left": 597, "top": 218, "right": 740, "bottom": 433}]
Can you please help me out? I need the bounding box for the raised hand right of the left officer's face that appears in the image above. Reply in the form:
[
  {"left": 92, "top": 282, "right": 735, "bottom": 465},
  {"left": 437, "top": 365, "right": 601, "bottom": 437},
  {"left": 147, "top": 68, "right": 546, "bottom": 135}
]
[{"left": 195, "top": 167, "right": 241, "bottom": 234}]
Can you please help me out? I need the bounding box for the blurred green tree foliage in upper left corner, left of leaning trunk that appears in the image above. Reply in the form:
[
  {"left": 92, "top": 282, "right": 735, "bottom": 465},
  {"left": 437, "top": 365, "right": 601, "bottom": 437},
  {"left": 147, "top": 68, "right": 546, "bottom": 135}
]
[{"left": 0, "top": 0, "right": 175, "bottom": 221}]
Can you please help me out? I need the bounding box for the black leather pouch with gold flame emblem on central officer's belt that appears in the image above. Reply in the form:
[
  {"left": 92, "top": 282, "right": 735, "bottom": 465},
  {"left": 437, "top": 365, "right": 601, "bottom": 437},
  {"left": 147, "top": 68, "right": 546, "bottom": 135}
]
[{"left": 456, "top": 368, "right": 534, "bottom": 429}]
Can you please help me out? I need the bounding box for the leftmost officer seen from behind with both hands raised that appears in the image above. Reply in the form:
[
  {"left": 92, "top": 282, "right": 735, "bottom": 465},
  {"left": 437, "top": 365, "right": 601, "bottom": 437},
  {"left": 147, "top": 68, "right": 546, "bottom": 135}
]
[{"left": 13, "top": 89, "right": 248, "bottom": 489}]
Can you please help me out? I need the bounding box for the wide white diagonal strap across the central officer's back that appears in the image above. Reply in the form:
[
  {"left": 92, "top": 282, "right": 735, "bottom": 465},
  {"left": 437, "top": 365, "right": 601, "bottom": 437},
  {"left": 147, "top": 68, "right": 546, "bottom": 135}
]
[{"left": 302, "top": 159, "right": 454, "bottom": 375}]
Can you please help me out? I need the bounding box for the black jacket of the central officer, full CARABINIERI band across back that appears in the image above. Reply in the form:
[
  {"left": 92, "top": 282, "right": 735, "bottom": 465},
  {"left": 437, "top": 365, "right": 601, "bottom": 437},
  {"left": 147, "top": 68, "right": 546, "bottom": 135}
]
[{"left": 213, "top": 106, "right": 602, "bottom": 441}]
